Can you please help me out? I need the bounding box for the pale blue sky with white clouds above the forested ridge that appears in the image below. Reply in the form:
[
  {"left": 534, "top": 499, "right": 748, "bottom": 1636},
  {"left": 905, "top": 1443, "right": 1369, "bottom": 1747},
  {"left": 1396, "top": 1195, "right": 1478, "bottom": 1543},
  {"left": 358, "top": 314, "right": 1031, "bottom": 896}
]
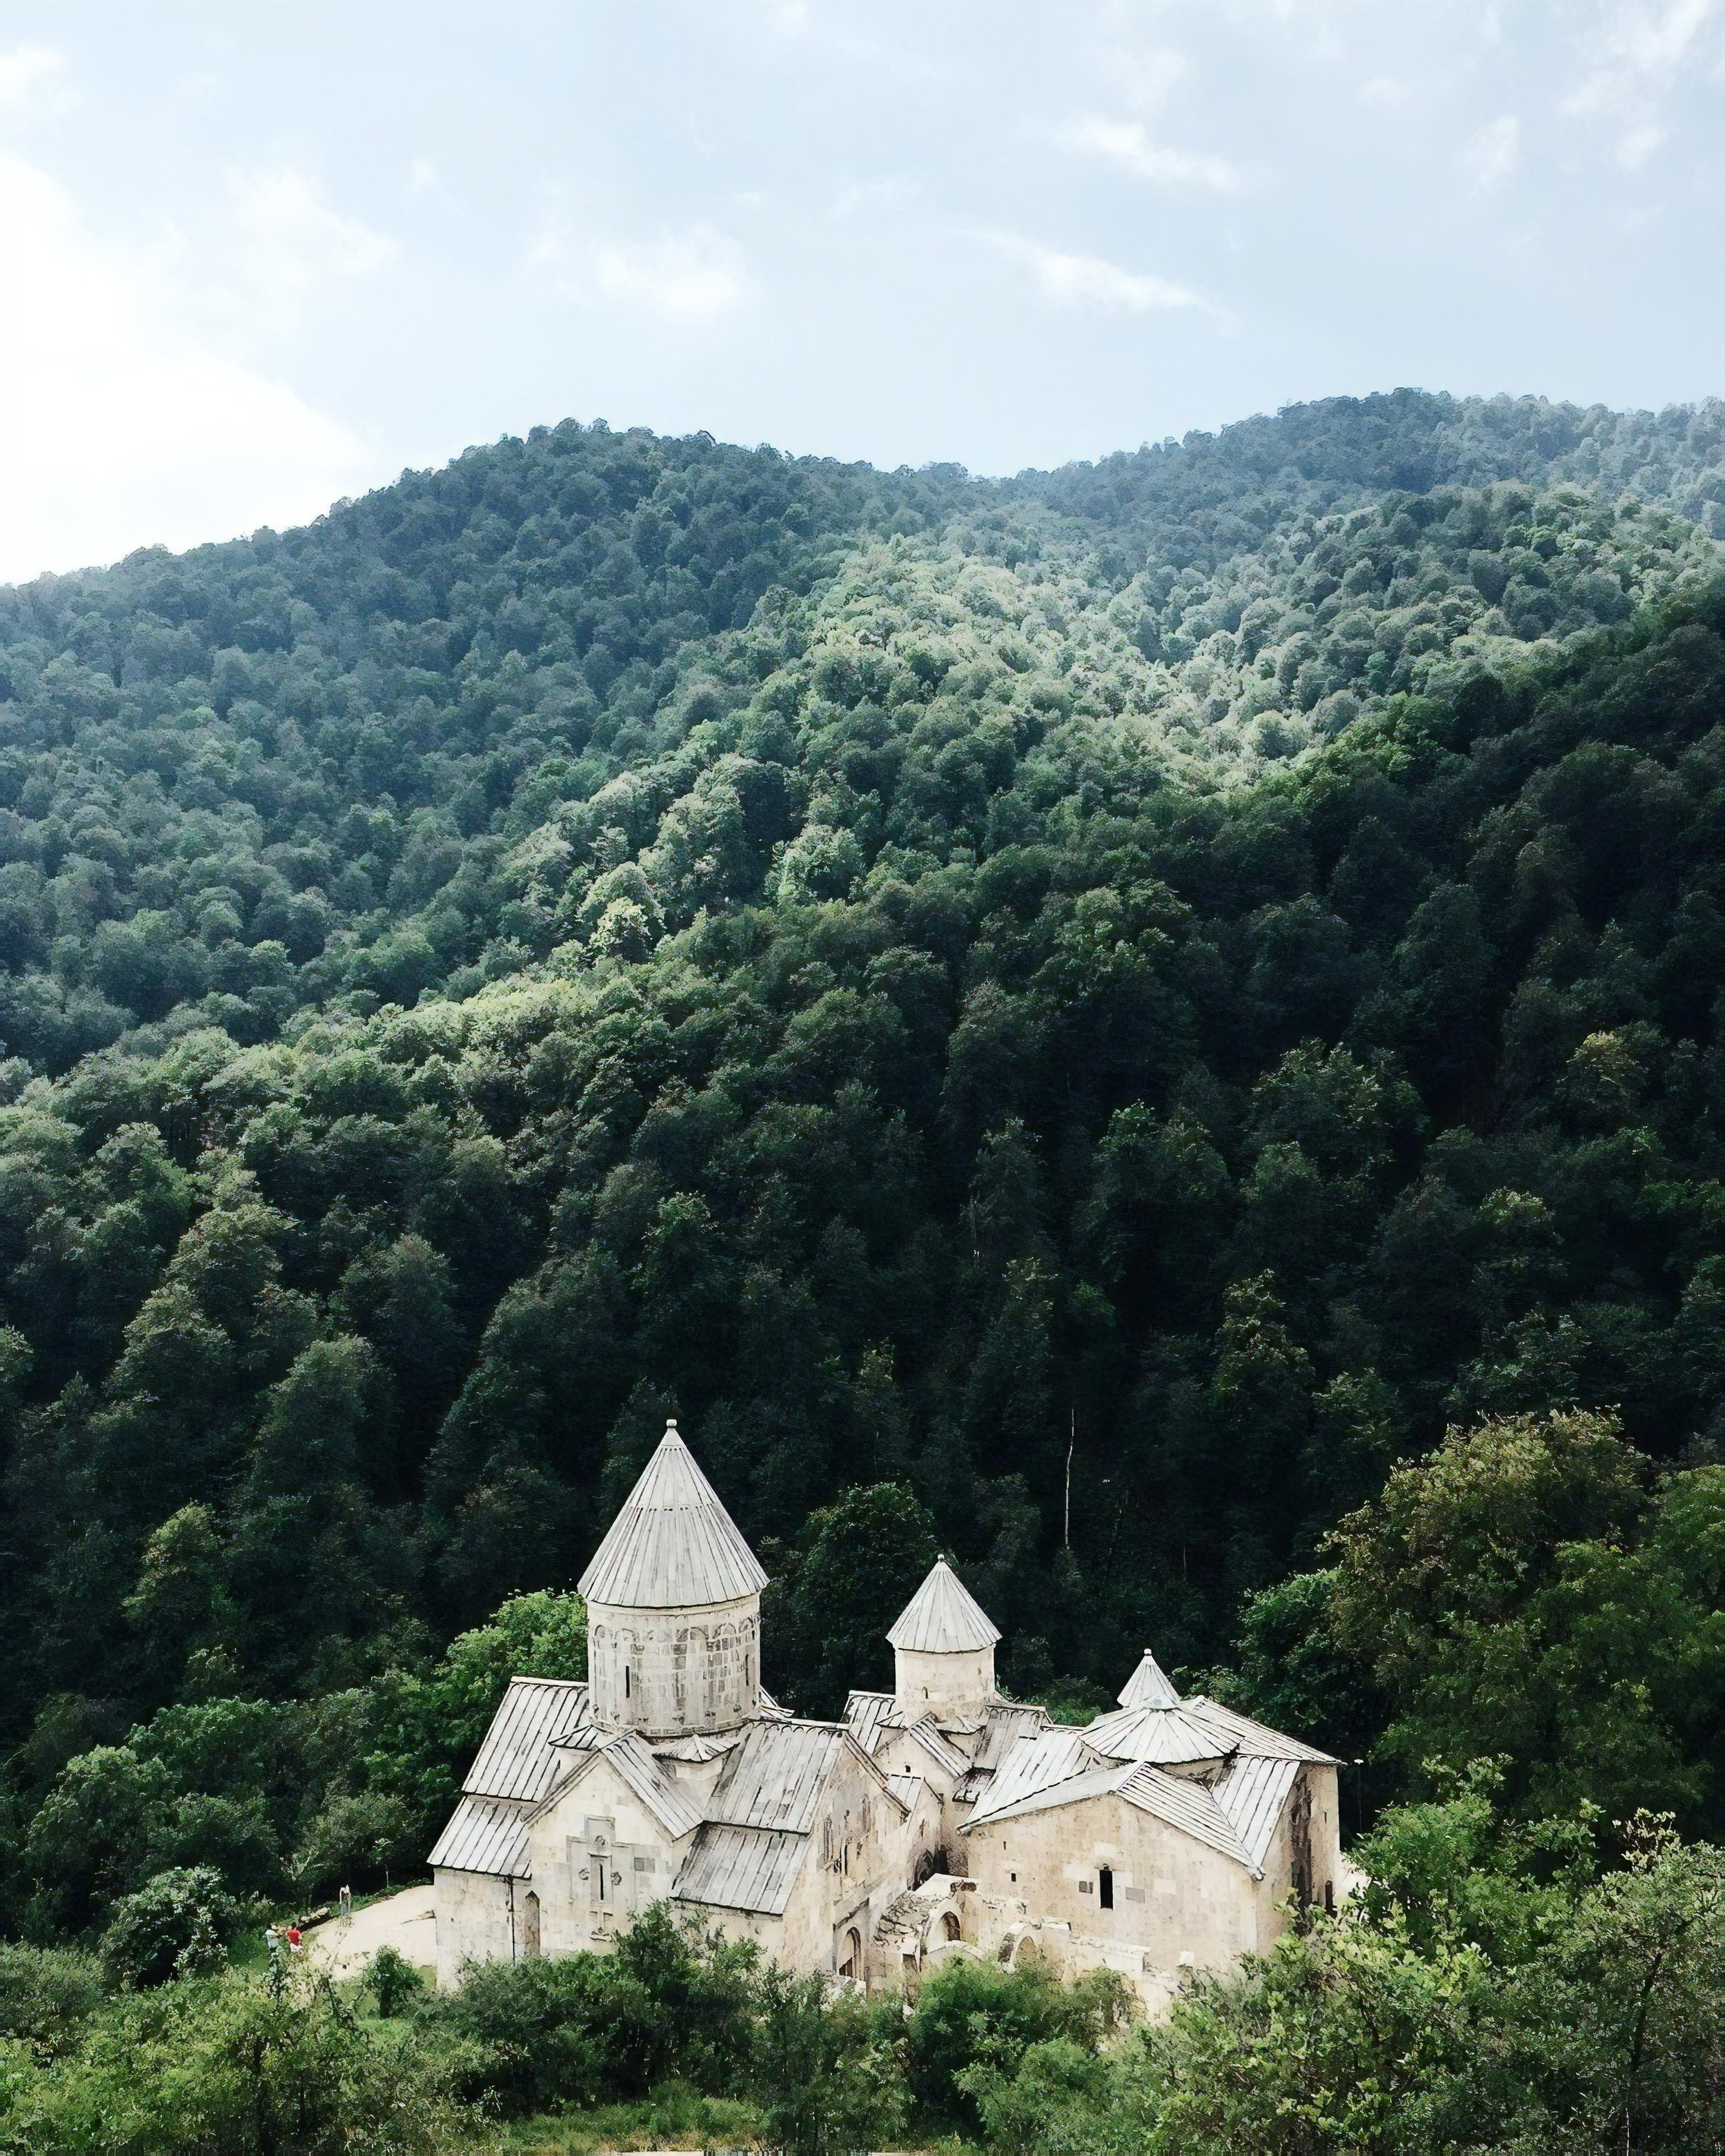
[{"left": 0, "top": 0, "right": 1725, "bottom": 578}]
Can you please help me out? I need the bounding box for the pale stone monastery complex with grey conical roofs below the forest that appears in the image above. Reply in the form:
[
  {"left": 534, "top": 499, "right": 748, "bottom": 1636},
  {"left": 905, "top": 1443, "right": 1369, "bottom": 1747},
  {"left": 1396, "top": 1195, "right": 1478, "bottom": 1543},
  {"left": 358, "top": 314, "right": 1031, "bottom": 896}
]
[{"left": 431, "top": 1423, "right": 1341, "bottom": 2012}]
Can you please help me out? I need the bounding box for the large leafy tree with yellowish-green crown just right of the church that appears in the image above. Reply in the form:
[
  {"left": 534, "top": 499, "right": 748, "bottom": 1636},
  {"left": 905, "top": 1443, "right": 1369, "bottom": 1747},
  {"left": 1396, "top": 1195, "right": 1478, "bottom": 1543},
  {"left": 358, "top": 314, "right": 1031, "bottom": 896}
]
[{"left": 1328, "top": 1414, "right": 1725, "bottom": 1817}]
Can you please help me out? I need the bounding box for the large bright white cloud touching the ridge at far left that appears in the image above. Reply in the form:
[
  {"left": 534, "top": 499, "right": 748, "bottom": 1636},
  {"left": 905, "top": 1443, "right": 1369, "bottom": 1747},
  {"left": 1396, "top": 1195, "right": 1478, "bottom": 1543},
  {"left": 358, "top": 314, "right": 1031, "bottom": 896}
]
[{"left": 0, "top": 159, "right": 386, "bottom": 578}]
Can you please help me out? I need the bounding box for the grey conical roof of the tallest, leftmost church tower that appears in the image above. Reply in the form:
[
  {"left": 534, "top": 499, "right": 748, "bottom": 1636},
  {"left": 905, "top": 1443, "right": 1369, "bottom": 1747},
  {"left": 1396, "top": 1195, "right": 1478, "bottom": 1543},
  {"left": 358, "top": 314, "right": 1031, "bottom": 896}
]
[{"left": 578, "top": 1421, "right": 768, "bottom": 1610}]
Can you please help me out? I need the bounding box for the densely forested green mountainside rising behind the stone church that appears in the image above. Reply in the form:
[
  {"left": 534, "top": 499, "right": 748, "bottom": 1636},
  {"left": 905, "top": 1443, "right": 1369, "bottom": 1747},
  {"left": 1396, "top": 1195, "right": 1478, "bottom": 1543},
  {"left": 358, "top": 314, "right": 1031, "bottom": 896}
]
[{"left": 0, "top": 393, "right": 1725, "bottom": 1938}]
